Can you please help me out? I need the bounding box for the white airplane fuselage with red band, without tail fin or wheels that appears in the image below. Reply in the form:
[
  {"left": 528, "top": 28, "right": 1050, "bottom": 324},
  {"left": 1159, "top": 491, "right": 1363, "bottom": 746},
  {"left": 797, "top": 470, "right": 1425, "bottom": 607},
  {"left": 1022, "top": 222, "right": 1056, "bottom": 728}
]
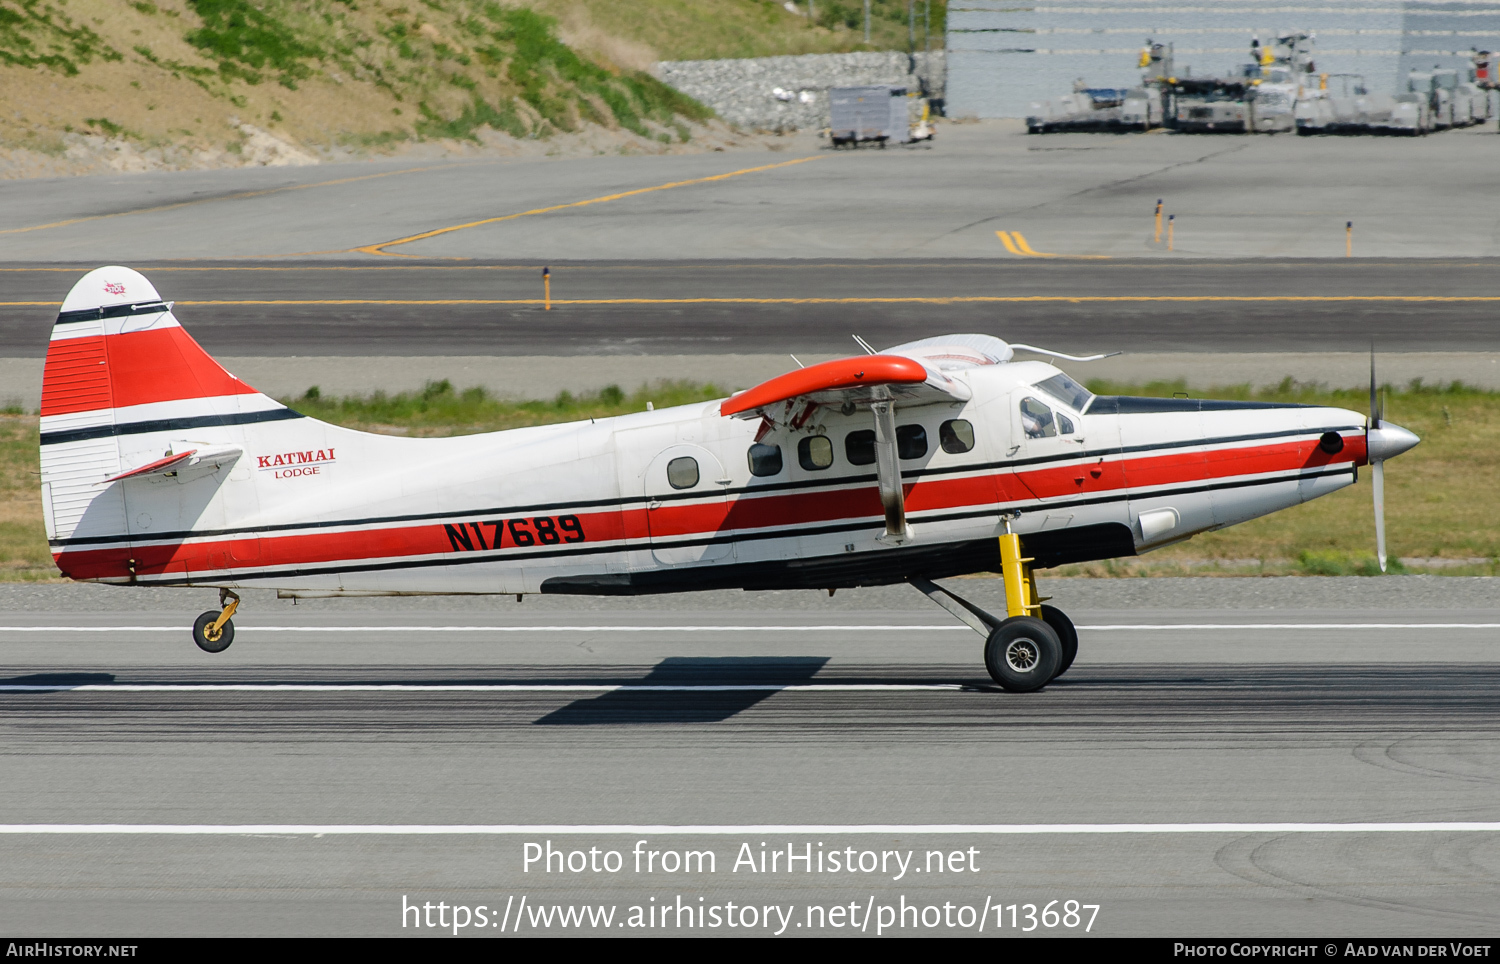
[{"left": 52, "top": 361, "right": 1365, "bottom": 594}]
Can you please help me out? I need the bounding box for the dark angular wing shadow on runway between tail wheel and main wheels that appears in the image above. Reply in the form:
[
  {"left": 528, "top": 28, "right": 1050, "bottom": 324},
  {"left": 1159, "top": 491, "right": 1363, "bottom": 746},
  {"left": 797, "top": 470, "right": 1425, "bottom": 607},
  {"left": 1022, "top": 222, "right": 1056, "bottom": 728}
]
[{"left": 537, "top": 657, "right": 828, "bottom": 726}]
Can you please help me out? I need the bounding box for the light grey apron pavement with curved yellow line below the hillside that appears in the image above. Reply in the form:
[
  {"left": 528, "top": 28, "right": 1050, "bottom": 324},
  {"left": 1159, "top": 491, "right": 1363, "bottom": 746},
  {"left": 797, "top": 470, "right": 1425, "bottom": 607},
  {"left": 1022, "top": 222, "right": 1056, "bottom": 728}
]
[{"left": 0, "top": 121, "right": 1500, "bottom": 265}]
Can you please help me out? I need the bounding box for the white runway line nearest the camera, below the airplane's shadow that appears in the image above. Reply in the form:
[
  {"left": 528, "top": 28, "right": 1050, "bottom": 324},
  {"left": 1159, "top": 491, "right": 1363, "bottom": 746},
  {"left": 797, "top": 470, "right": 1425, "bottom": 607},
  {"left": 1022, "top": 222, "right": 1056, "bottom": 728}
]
[{"left": 0, "top": 822, "right": 1500, "bottom": 837}]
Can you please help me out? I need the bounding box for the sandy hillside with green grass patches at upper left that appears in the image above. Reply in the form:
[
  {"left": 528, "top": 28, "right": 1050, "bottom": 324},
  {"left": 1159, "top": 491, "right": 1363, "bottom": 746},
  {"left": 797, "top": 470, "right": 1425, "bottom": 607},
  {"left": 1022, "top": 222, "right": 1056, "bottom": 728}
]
[{"left": 0, "top": 0, "right": 942, "bottom": 153}]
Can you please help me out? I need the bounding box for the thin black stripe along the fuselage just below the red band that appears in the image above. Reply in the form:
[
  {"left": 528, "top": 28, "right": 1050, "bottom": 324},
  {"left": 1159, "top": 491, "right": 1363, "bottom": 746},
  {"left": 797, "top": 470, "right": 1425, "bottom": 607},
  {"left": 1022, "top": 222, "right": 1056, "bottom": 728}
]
[{"left": 123, "top": 468, "right": 1356, "bottom": 586}]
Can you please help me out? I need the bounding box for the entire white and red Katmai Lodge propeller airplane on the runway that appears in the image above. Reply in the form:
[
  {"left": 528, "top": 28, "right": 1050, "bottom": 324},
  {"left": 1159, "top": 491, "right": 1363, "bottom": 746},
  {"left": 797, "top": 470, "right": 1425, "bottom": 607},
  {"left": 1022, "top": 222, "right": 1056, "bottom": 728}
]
[{"left": 41, "top": 267, "right": 1419, "bottom": 691}]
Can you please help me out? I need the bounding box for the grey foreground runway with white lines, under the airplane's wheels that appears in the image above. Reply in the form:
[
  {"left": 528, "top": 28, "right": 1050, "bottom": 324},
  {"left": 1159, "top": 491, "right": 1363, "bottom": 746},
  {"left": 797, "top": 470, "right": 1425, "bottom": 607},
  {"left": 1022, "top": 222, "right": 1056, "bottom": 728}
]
[{"left": 0, "top": 577, "right": 1500, "bottom": 936}]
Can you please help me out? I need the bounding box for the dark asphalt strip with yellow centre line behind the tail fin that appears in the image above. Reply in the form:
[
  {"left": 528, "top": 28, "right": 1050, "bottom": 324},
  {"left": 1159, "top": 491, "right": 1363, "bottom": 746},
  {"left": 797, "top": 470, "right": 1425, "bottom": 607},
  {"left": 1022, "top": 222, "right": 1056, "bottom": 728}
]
[{"left": 0, "top": 259, "right": 1500, "bottom": 357}]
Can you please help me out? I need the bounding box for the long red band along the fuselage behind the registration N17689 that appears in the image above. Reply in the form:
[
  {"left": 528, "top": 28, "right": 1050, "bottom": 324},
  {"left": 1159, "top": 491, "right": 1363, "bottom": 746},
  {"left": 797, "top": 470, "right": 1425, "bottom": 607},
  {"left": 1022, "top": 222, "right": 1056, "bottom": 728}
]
[{"left": 54, "top": 435, "right": 1364, "bottom": 579}]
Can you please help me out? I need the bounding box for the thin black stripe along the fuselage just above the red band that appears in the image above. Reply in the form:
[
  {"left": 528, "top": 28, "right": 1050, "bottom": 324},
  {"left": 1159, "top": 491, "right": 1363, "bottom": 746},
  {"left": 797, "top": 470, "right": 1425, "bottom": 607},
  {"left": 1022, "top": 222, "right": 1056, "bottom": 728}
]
[{"left": 52, "top": 422, "right": 1364, "bottom": 547}]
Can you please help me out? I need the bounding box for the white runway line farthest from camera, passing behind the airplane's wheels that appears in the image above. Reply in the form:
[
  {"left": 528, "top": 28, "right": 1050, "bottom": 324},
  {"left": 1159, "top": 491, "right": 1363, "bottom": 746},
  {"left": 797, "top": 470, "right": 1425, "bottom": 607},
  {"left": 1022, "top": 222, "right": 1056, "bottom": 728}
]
[{"left": 0, "top": 622, "right": 1500, "bottom": 633}]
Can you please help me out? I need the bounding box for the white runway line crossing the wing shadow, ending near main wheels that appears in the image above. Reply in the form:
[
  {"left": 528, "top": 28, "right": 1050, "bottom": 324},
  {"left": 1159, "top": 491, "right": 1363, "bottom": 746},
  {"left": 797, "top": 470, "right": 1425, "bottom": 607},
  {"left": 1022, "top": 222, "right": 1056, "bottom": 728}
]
[{"left": 0, "top": 682, "right": 966, "bottom": 693}]
